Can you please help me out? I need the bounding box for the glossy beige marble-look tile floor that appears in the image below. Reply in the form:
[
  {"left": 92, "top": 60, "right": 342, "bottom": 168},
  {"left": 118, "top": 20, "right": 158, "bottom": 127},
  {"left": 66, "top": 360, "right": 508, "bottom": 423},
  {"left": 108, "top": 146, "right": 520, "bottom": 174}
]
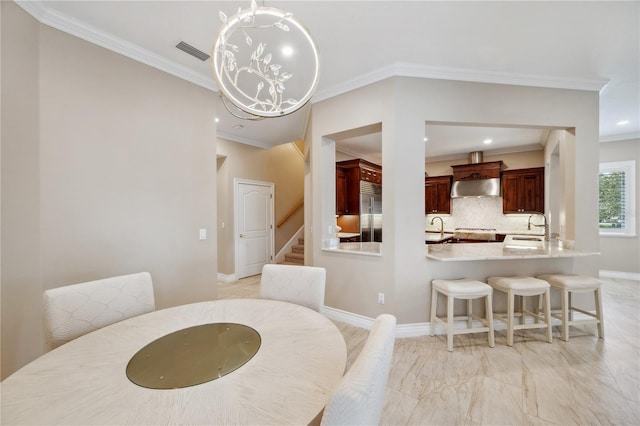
[{"left": 218, "top": 276, "right": 640, "bottom": 425}]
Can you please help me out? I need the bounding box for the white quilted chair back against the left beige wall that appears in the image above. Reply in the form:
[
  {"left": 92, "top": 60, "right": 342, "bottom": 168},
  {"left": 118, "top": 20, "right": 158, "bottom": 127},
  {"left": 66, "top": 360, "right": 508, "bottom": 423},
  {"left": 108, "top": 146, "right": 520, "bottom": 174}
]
[{"left": 43, "top": 272, "right": 155, "bottom": 349}]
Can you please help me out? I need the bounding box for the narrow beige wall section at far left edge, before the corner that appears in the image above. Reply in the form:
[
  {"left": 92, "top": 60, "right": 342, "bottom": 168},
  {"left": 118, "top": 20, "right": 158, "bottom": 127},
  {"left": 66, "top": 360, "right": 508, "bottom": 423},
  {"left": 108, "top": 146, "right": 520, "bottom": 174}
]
[{"left": 0, "top": 2, "right": 44, "bottom": 378}]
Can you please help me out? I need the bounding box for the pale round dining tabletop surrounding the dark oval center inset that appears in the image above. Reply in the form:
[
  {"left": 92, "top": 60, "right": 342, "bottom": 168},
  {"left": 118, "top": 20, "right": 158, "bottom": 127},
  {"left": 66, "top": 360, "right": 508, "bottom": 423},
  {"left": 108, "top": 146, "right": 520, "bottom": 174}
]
[{"left": 0, "top": 299, "right": 347, "bottom": 425}]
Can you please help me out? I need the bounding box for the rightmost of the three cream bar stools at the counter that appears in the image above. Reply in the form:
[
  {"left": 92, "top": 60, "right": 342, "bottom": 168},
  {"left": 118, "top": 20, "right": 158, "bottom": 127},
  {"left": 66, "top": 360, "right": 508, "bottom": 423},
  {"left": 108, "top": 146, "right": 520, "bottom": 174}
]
[{"left": 538, "top": 274, "right": 604, "bottom": 342}]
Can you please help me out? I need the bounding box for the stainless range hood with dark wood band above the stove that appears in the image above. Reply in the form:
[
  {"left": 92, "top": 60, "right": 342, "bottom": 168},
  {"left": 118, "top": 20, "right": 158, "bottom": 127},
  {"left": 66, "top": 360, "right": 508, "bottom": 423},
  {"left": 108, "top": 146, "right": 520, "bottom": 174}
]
[{"left": 451, "top": 151, "right": 502, "bottom": 198}]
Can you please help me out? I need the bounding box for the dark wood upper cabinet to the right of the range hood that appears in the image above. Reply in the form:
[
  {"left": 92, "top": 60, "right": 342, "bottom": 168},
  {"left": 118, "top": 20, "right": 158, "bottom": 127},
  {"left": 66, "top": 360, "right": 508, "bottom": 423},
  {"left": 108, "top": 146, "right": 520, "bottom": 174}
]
[{"left": 502, "top": 167, "right": 544, "bottom": 214}]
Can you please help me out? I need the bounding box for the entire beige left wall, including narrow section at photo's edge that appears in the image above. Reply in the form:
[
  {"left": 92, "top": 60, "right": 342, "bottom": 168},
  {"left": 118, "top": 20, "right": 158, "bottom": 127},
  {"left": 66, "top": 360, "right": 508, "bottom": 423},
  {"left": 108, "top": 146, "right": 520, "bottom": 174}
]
[{"left": 2, "top": 2, "right": 217, "bottom": 377}]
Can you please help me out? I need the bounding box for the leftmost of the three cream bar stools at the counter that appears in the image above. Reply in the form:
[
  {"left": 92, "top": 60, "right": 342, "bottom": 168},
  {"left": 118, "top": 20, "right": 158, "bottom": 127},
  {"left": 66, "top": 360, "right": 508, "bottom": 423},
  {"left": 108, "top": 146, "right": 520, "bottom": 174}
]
[{"left": 429, "top": 279, "right": 495, "bottom": 352}]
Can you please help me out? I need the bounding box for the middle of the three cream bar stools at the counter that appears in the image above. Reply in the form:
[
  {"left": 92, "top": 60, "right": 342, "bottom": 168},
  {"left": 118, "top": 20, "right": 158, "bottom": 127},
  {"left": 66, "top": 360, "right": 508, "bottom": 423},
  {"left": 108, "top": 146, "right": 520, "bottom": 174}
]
[{"left": 487, "top": 277, "right": 553, "bottom": 346}]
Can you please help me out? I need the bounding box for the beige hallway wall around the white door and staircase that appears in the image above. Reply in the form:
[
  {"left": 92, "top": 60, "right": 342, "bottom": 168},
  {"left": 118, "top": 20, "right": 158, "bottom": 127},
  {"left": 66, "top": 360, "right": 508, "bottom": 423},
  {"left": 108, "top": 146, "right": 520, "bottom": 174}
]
[{"left": 217, "top": 139, "right": 304, "bottom": 275}]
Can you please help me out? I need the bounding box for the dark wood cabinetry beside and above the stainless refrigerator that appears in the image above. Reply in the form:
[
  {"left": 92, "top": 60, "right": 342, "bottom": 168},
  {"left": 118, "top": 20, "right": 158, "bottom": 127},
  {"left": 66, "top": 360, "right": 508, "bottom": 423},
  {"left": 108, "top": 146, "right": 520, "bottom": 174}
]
[{"left": 336, "top": 159, "right": 382, "bottom": 215}]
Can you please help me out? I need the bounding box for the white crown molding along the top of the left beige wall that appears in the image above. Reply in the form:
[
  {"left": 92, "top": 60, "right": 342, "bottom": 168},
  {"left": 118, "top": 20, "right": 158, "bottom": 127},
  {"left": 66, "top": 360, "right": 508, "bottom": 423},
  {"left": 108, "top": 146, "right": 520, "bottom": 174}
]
[{"left": 15, "top": 0, "right": 218, "bottom": 92}]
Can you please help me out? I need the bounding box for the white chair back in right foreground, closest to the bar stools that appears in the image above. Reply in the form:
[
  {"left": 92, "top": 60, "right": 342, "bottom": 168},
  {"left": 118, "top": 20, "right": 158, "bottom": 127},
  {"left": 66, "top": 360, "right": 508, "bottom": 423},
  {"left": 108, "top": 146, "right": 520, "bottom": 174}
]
[{"left": 320, "top": 314, "right": 396, "bottom": 425}]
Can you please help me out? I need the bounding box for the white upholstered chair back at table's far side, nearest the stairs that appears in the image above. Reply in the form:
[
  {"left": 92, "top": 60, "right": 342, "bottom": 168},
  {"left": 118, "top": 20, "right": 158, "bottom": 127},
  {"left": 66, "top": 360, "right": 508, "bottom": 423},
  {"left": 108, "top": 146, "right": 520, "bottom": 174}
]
[{"left": 260, "top": 264, "right": 326, "bottom": 312}]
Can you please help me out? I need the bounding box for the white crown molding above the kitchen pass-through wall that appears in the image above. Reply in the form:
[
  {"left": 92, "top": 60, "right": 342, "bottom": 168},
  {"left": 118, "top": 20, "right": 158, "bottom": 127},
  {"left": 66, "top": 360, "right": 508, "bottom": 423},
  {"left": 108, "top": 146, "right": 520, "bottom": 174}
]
[{"left": 313, "top": 62, "right": 609, "bottom": 102}]
